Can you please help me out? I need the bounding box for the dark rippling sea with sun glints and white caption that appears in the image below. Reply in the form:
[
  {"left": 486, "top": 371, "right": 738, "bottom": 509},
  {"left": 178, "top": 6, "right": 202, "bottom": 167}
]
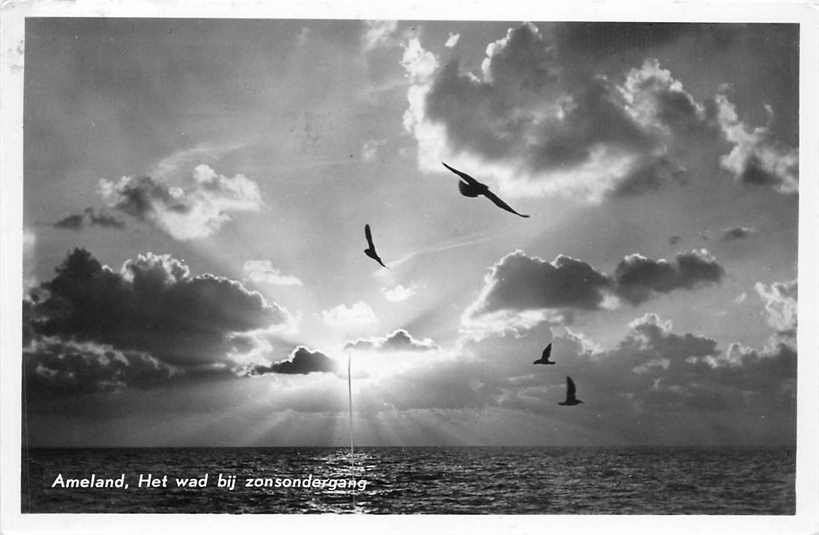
[{"left": 22, "top": 447, "right": 795, "bottom": 515}]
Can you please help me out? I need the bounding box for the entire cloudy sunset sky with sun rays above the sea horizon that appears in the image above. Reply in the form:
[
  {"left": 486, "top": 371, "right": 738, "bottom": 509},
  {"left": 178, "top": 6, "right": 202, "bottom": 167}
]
[{"left": 22, "top": 19, "right": 799, "bottom": 447}]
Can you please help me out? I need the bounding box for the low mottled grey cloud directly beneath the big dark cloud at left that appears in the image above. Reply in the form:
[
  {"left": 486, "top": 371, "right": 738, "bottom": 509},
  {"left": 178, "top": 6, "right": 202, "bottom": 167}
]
[{"left": 23, "top": 338, "right": 183, "bottom": 399}]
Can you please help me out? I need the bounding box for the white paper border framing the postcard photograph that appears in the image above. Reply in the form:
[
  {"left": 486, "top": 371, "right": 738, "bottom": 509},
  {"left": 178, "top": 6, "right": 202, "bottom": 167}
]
[{"left": 0, "top": 0, "right": 819, "bottom": 535}]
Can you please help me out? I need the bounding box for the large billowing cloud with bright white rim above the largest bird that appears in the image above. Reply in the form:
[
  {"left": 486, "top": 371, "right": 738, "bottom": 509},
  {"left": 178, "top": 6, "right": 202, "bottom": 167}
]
[{"left": 404, "top": 24, "right": 658, "bottom": 199}]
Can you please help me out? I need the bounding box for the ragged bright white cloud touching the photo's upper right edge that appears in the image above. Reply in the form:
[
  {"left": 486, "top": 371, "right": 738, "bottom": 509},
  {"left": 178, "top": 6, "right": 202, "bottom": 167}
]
[{"left": 716, "top": 94, "right": 799, "bottom": 194}]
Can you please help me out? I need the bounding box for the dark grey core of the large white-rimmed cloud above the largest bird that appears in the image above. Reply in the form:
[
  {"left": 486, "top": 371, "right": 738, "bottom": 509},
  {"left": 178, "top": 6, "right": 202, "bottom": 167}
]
[{"left": 426, "top": 24, "right": 652, "bottom": 175}]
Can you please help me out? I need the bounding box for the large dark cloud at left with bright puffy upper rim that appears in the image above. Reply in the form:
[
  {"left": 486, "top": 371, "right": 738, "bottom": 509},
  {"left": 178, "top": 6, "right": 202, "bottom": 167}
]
[{"left": 28, "top": 249, "right": 289, "bottom": 365}]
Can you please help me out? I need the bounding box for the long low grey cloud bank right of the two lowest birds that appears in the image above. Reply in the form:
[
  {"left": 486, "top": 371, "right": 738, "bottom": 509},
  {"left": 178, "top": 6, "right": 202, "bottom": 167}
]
[{"left": 501, "top": 314, "right": 796, "bottom": 418}]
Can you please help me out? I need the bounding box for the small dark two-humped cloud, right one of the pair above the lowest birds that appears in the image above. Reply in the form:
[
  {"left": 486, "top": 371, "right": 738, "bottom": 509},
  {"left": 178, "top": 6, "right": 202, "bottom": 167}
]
[{"left": 614, "top": 249, "right": 725, "bottom": 305}]
